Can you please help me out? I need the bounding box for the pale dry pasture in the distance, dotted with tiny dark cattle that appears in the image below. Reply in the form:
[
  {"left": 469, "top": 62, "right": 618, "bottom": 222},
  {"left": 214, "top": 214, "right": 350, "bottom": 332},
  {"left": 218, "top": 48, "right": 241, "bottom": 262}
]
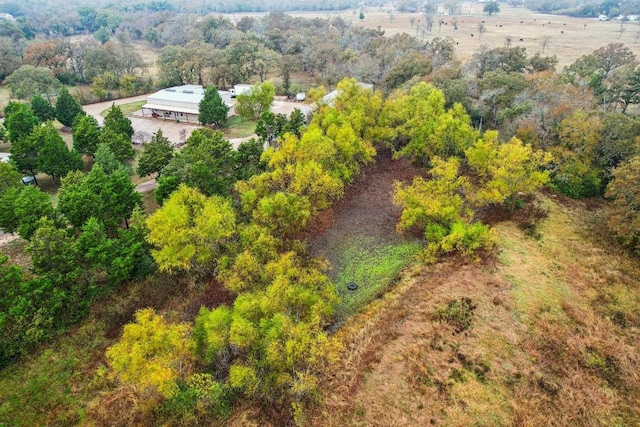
[{"left": 227, "top": 2, "right": 640, "bottom": 70}]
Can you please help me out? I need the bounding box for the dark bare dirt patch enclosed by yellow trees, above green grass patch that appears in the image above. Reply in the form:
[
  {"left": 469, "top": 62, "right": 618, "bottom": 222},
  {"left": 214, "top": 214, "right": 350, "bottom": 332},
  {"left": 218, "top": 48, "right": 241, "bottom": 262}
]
[{"left": 304, "top": 148, "right": 421, "bottom": 272}]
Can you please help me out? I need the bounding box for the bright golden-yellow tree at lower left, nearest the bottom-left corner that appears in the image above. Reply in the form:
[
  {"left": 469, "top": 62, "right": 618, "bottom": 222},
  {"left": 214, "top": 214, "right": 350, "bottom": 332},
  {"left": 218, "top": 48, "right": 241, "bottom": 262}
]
[{"left": 106, "top": 309, "right": 192, "bottom": 399}]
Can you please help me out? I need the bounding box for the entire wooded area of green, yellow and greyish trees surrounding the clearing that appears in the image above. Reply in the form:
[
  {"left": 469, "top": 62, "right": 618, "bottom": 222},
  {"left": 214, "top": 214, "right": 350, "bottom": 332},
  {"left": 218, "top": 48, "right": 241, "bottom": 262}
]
[{"left": 0, "top": 2, "right": 640, "bottom": 426}]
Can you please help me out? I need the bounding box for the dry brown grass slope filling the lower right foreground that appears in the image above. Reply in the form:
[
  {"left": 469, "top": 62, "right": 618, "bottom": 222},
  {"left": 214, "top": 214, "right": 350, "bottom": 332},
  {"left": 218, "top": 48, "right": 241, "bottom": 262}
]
[{"left": 309, "top": 198, "right": 640, "bottom": 426}]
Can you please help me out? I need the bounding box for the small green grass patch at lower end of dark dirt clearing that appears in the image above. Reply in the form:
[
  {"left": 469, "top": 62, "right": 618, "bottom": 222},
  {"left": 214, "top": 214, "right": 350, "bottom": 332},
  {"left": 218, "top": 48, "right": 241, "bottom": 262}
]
[{"left": 334, "top": 237, "right": 422, "bottom": 320}]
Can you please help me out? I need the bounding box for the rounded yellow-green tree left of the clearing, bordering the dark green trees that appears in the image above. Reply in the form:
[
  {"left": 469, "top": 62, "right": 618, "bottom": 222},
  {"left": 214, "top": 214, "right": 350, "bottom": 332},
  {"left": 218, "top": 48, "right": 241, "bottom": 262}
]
[{"left": 147, "top": 185, "right": 235, "bottom": 272}]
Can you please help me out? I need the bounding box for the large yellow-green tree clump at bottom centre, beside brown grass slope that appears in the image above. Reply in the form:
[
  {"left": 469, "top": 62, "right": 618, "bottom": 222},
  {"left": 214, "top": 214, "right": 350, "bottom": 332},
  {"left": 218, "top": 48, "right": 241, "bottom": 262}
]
[{"left": 194, "top": 252, "right": 339, "bottom": 404}]
